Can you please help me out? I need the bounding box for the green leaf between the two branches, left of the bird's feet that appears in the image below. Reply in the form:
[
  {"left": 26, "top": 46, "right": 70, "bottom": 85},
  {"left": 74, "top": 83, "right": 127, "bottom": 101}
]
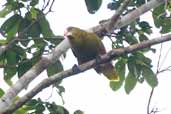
[{"left": 47, "top": 61, "right": 63, "bottom": 76}]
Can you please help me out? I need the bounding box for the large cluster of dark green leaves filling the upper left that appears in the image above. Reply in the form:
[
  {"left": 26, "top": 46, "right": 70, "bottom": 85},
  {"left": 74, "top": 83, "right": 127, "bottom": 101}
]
[{"left": 0, "top": 0, "right": 63, "bottom": 85}]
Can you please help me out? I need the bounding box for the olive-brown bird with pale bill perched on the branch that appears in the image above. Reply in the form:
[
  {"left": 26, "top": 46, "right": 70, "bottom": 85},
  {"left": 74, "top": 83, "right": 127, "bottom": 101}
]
[{"left": 64, "top": 27, "right": 119, "bottom": 81}]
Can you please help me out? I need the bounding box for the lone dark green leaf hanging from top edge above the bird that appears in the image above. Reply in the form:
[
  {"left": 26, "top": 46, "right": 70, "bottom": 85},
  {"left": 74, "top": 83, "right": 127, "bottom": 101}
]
[{"left": 85, "top": 0, "right": 102, "bottom": 14}]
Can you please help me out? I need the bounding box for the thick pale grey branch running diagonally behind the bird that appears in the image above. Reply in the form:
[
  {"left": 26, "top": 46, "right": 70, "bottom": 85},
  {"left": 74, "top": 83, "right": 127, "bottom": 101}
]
[{"left": 0, "top": 0, "right": 164, "bottom": 113}]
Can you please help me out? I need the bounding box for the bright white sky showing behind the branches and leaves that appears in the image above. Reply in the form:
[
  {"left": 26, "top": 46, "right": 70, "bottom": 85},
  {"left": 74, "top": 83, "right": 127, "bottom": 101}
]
[{"left": 0, "top": 0, "right": 171, "bottom": 114}]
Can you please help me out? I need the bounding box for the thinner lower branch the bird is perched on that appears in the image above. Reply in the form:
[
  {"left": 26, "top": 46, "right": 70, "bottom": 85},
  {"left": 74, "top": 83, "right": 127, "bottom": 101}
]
[{"left": 3, "top": 34, "right": 171, "bottom": 114}]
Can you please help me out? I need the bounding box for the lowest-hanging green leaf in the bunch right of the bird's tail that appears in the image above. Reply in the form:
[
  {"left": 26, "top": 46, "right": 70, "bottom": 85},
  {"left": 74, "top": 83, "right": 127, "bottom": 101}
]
[{"left": 124, "top": 72, "right": 137, "bottom": 94}]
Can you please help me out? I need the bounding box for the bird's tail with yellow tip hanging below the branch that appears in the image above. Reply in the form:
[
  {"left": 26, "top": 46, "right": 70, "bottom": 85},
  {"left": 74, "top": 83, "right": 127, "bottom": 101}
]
[{"left": 102, "top": 63, "right": 120, "bottom": 81}]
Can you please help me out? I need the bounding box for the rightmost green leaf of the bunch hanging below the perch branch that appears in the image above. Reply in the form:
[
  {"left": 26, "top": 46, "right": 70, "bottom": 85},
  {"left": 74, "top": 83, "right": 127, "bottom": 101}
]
[{"left": 142, "top": 67, "right": 158, "bottom": 88}]
